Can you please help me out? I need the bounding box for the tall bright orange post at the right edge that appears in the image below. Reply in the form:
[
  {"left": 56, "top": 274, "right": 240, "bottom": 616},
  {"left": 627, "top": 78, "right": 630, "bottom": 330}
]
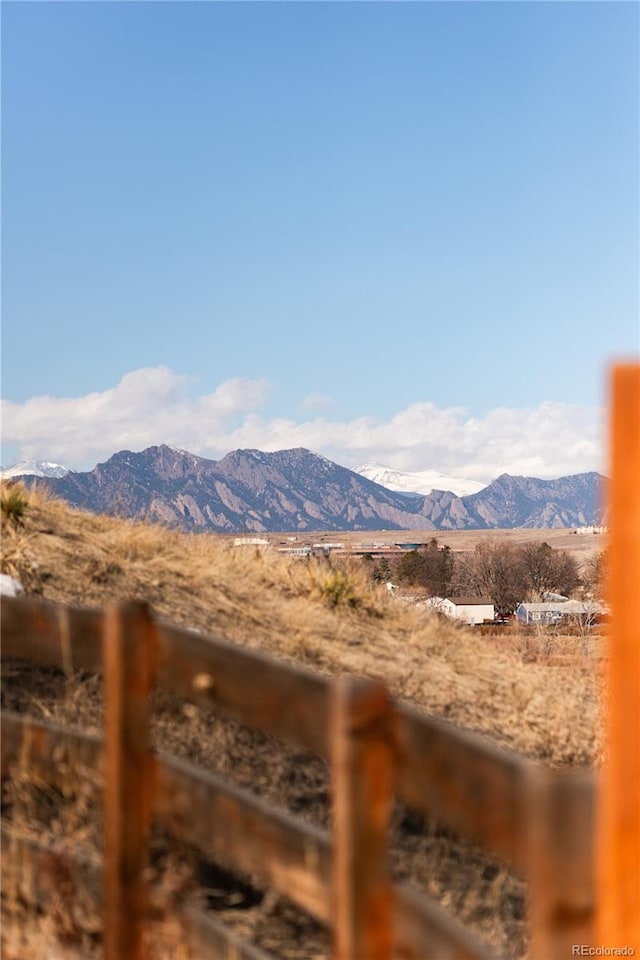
[{"left": 597, "top": 363, "right": 640, "bottom": 956}]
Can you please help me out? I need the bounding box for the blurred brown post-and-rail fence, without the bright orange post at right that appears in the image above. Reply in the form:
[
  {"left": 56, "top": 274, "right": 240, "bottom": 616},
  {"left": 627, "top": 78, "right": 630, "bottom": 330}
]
[{"left": 2, "top": 598, "right": 594, "bottom": 960}]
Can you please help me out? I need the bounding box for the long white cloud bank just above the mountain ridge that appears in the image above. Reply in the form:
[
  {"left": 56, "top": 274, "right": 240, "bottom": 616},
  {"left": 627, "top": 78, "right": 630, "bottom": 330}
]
[{"left": 2, "top": 367, "right": 605, "bottom": 482}]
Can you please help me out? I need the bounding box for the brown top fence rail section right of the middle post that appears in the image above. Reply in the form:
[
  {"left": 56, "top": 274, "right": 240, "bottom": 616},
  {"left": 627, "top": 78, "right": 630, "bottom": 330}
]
[{"left": 396, "top": 704, "right": 535, "bottom": 869}]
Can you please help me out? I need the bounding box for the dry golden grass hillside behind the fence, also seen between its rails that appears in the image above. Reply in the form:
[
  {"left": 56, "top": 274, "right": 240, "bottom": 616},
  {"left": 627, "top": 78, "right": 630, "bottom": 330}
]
[{"left": 2, "top": 486, "right": 599, "bottom": 960}]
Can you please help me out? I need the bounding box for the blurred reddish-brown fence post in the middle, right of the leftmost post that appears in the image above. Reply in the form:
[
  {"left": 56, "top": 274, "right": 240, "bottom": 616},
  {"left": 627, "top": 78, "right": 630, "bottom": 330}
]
[{"left": 331, "top": 678, "right": 394, "bottom": 960}]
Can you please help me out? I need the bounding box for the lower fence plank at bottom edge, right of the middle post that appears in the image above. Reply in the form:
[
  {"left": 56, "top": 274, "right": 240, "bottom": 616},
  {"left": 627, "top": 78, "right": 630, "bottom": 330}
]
[{"left": 394, "top": 884, "right": 495, "bottom": 960}]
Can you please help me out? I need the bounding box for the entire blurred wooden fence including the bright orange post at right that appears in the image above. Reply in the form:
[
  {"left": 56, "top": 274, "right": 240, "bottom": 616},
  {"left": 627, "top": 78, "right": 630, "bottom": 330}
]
[{"left": 2, "top": 367, "right": 640, "bottom": 960}]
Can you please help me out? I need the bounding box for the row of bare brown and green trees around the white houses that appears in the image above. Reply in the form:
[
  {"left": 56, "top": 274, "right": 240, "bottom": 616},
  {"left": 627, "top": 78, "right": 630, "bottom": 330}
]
[{"left": 369, "top": 537, "right": 605, "bottom": 614}]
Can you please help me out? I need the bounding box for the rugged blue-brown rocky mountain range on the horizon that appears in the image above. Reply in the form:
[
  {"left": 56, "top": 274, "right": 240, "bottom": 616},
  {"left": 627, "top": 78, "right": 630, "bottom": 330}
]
[{"left": 7, "top": 445, "right": 606, "bottom": 533}]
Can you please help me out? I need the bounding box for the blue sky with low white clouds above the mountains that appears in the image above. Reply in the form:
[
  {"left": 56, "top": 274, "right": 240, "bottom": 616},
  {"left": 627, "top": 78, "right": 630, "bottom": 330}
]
[{"left": 2, "top": 2, "right": 639, "bottom": 480}]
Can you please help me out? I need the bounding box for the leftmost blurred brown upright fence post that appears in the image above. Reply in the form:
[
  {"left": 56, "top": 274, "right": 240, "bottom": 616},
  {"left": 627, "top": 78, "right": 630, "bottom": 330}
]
[{"left": 103, "top": 602, "right": 155, "bottom": 960}]
